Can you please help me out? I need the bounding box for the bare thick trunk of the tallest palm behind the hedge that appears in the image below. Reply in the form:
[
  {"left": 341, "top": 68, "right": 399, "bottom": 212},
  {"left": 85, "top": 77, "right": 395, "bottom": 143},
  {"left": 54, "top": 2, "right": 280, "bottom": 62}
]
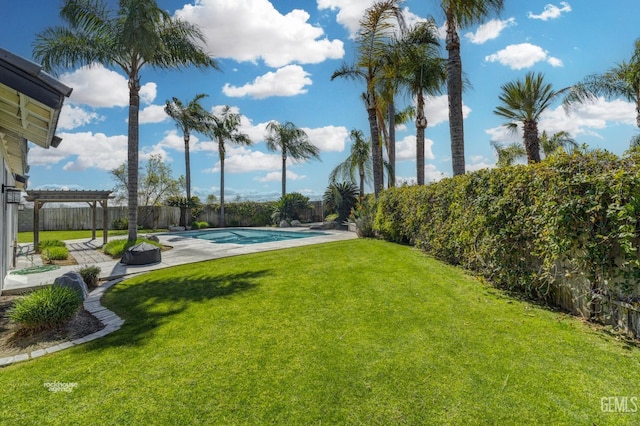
[{"left": 447, "top": 11, "right": 465, "bottom": 176}]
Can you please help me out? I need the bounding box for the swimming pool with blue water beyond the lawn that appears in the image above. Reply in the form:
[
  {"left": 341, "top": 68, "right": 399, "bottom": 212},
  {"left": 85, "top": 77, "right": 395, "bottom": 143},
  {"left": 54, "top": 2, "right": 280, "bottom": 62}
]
[{"left": 171, "top": 228, "right": 327, "bottom": 244}]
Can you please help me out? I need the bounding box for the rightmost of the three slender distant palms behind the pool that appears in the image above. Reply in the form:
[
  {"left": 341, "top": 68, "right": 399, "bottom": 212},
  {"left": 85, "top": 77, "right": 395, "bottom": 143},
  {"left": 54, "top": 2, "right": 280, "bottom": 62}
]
[{"left": 265, "top": 121, "right": 320, "bottom": 197}]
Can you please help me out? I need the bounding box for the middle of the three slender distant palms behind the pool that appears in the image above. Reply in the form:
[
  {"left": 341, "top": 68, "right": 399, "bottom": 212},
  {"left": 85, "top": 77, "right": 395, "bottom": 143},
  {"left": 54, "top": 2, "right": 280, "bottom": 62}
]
[{"left": 205, "top": 105, "right": 251, "bottom": 228}]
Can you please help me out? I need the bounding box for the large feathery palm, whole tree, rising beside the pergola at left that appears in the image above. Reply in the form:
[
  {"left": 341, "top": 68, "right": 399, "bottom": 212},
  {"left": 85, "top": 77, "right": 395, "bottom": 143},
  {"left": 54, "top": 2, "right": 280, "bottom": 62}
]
[{"left": 33, "top": 0, "right": 217, "bottom": 241}]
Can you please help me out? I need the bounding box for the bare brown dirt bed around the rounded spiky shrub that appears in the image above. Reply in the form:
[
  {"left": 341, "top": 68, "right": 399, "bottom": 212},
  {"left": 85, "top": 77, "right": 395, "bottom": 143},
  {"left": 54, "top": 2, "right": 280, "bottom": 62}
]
[{"left": 0, "top": 296, "right": 104, "bottom": 358}]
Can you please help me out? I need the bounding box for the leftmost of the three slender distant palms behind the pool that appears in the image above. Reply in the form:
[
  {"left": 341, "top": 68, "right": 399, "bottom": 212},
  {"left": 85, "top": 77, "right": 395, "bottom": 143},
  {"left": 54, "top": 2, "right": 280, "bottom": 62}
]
[{"left": 164, "top": 93, "right": 208, "bottom": 225}]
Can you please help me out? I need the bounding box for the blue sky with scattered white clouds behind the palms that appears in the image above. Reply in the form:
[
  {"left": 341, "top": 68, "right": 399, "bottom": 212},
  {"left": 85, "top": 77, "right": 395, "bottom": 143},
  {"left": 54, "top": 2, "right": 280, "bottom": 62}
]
[{"left": 0, "top": 0, "right": 640, "bottom": 200}]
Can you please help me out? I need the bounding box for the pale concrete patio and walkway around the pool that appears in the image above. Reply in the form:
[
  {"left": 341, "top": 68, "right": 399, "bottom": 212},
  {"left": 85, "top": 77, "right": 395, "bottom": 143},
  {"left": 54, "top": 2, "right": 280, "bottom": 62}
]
[{"left": 2, "top": 228, "right": 357, "bottom": 295}]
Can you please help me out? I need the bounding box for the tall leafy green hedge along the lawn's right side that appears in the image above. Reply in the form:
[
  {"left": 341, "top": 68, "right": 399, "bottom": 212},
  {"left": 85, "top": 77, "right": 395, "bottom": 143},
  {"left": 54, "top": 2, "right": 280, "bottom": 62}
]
[{"left": 375, "top": 151, "right": 640, "bottom": 335}]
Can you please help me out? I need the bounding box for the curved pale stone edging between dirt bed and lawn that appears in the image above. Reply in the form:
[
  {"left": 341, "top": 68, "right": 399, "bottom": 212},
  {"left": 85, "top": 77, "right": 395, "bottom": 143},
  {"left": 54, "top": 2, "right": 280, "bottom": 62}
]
[{"left": 0, "top": 278, "right": 124, "bottom": 367}]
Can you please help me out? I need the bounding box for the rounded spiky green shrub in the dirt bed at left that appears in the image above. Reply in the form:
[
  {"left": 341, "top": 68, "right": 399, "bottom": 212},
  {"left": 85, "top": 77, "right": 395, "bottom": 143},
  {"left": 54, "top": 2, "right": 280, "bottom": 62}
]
[{"left": 8, "top": 285, "right": 82, "bottom": 333}]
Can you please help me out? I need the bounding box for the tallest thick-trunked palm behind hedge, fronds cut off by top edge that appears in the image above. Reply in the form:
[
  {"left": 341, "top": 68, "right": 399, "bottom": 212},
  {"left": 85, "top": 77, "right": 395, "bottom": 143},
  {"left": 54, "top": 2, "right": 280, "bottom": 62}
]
[{"left": 441, "top": 0, "right": 504, "bottom": 176}]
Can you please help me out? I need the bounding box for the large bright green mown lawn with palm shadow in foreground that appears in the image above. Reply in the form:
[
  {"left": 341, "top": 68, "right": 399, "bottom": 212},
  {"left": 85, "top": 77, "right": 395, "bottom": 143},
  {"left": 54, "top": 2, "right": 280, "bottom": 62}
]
[{"left": 0, "top": 240, "right": 640, "bottom": 425}]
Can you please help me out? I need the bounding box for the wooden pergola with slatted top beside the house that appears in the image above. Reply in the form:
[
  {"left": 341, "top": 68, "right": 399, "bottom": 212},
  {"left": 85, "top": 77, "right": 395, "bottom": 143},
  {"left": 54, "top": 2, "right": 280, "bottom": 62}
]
[{"left": 25, "top": 190, "right": 114, "bottom": 245}]
